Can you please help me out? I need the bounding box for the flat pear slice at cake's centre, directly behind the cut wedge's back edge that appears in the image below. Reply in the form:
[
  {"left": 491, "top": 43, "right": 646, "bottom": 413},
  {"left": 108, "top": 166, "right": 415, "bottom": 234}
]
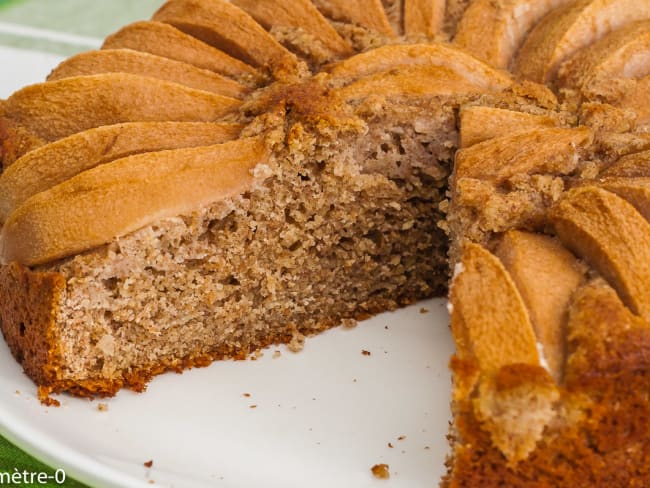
[{"left": 334, "top": 65, "right": 504, "bottom": 101}]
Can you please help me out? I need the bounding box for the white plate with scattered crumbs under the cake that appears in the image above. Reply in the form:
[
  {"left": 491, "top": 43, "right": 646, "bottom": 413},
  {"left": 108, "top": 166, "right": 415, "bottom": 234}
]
[{"left": 0, "top": 48, "right": 453, "bottom": 488}]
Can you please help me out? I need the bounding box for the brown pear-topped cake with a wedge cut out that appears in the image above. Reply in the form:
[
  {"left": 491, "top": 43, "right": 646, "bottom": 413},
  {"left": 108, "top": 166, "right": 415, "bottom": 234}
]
[{"left": 0, "top": 0, "right": 650, "bottom": 487}]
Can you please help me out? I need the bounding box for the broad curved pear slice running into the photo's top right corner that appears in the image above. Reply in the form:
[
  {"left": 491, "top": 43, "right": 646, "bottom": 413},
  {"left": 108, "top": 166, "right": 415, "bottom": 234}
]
[{"left": 514, "top": 0, "right": 650, "bottom": 83}]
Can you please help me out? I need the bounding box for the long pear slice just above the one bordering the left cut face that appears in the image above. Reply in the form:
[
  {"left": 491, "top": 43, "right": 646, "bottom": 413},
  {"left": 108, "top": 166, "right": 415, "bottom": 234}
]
[{"left": 0, "top": 122, "right": 241, "bottom": 222}]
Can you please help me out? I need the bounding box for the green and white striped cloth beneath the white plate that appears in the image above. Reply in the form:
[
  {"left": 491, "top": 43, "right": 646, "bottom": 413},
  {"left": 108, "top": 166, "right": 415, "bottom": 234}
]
[{"left": 0, "top": 0, "right": 163, "bottom": 487}]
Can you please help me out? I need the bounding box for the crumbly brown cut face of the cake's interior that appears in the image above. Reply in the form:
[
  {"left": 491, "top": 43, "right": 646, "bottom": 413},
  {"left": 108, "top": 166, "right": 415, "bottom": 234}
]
[{"left": 13, "top": 92, "right": 457, "bottom": 394}]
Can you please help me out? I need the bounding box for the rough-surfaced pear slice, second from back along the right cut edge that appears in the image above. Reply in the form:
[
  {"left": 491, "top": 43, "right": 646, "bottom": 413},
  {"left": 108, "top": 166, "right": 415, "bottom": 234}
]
[{"left": 455, "top": 127, "right": 593, "bottom": 184}]
